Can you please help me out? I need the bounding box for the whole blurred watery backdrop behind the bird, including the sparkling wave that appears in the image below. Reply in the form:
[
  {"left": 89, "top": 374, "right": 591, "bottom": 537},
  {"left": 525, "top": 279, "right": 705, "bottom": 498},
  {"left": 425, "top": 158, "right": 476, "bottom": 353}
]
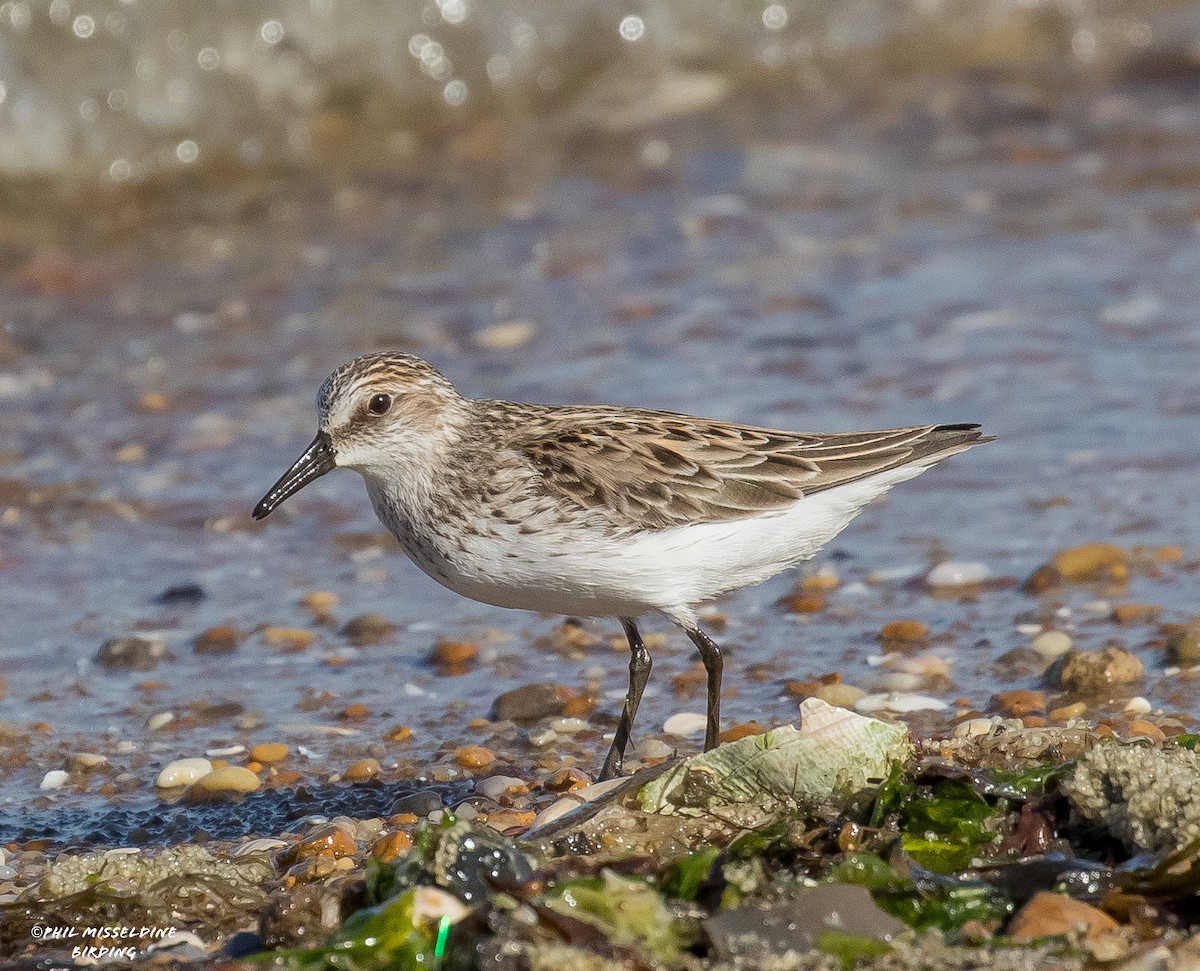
[{"left": 0, "top": 0, "right": 1200, "bottom": 811}]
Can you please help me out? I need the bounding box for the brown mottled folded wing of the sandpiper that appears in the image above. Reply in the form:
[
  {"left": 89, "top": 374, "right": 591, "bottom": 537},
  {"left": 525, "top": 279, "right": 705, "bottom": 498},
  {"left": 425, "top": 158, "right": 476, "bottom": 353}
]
[{"left": 512, "top": 408, "right": 990, "bottom": 529}]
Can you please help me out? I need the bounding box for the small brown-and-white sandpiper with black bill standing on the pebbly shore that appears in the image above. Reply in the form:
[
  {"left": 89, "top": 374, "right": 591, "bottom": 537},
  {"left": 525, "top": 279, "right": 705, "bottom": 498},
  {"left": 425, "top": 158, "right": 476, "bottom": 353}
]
[{"left": 253, "top": 353, "right": 991, "bottom": 779}]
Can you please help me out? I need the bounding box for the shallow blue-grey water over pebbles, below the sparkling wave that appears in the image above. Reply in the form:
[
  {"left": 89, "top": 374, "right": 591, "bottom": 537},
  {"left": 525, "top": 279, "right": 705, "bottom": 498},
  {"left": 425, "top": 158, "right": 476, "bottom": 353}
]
[{"left": 0, "top": 7, "right": 1200, "bottom": 841}]
